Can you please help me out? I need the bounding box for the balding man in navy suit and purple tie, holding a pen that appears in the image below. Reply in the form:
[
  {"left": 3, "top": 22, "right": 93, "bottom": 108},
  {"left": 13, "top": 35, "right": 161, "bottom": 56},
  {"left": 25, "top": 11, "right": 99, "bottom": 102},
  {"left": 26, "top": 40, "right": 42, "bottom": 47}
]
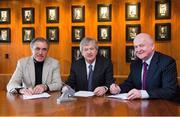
[{"left": 110, "top": 33, "right": 177, "bottom": 100}]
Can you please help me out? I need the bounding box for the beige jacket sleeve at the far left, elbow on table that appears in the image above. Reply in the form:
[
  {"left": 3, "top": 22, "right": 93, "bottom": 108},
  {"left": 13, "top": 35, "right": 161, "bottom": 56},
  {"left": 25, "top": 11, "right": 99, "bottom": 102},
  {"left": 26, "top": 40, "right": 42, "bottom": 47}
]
[{"left": 7, "top": 61, "right": 23, "bottom": 92}]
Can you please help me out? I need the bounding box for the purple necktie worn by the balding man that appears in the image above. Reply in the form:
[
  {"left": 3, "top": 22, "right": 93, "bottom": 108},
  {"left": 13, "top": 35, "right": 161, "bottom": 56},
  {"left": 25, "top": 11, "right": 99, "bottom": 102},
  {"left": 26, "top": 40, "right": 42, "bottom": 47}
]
[{"left": 142, "top": 62, "right": 148, "bottom": 90}]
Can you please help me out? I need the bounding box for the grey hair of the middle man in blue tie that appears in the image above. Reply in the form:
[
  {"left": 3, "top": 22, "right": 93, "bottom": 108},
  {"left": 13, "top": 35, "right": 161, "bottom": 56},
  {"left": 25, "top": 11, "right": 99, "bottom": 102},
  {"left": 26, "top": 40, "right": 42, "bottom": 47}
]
[{"left": 79, "top": 37, "right": 98, "bottom": 53}]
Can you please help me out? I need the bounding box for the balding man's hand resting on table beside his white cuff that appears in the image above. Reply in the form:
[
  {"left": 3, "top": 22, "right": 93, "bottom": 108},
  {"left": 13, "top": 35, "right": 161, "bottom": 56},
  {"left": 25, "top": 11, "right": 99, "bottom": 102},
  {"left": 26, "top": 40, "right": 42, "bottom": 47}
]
[{"left": 127, "top": 89, "right": 141, "bottom": 100}]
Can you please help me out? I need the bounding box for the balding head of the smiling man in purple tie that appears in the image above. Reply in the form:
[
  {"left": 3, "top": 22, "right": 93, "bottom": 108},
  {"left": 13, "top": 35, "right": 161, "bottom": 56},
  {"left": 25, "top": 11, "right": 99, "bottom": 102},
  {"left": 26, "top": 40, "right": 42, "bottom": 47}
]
[{"left": 134, "top": 33, "right": 154, "bottom": 61}]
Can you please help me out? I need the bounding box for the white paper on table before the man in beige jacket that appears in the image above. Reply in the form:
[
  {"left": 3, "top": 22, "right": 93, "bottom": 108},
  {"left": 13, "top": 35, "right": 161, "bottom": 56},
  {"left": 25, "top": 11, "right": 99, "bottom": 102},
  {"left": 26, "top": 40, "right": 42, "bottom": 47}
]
[{"left": 23, "top": 93, "right": 51, "bottom": 100}]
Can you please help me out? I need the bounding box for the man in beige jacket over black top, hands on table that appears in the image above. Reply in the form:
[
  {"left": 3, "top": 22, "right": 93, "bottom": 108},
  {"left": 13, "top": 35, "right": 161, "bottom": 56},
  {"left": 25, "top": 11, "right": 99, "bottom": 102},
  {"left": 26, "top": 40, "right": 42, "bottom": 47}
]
[{"left": 7, "top": 37, "right": 62, "bottom": 95}]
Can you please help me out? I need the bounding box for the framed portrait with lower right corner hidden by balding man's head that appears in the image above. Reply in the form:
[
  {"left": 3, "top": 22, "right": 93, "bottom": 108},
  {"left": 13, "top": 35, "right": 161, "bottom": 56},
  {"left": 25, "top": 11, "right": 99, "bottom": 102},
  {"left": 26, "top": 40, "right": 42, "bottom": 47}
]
[{"left": 126, "top": 24, "right": 141, "bottom": 42}]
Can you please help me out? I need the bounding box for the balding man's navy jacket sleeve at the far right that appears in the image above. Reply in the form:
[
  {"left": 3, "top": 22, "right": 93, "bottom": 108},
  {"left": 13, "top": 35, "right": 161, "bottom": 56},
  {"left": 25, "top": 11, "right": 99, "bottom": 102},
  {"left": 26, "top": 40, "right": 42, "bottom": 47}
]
[{"left": 147, "top": 59, "right": 177, "bottom": 99}]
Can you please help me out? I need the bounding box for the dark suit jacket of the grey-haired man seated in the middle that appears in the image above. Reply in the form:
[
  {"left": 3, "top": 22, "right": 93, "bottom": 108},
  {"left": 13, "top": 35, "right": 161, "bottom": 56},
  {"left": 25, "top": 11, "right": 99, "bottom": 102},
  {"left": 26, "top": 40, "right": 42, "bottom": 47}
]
[{"left": 66, "top": 56, "right": 114, "bottom": 91}]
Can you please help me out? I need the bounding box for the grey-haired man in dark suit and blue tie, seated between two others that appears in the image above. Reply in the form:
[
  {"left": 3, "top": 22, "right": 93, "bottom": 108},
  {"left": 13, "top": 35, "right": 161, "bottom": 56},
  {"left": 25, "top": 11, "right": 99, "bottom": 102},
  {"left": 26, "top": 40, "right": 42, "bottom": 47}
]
[{"left": 66, "top": 37, "right": 114, "bottom": 96}]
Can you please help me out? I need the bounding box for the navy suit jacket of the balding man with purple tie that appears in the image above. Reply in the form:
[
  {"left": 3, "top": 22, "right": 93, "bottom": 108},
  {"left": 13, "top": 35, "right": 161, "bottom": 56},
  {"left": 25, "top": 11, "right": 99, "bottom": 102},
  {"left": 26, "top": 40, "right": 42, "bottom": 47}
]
[{"left": 120, "top": 52, "right": 177, "bottom": 99}]
